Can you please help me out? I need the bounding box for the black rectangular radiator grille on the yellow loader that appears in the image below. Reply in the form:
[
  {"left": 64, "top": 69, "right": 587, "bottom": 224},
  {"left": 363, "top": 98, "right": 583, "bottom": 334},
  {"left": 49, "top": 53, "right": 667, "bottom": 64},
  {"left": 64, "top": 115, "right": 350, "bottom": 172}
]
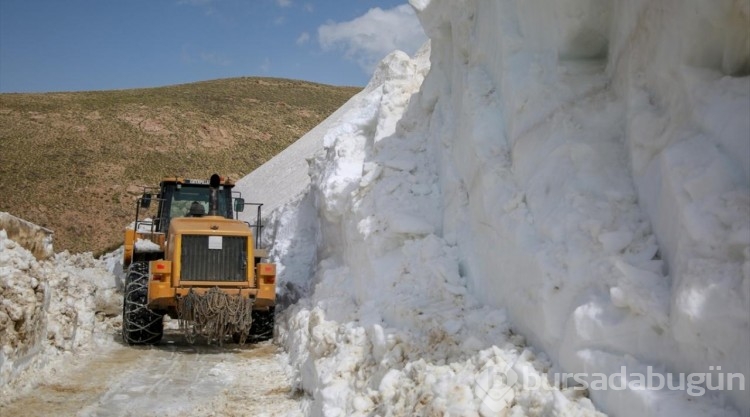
[{"left": 180, "top": 235, "right": 247, "bottom": 282}]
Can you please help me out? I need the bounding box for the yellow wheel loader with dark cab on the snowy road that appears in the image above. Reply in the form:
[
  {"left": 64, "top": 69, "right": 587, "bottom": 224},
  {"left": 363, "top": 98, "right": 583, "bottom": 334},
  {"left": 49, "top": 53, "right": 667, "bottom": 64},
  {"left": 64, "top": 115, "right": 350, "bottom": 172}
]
[{"left": 122, "top": 174, "right": 276, "bottom": 345}]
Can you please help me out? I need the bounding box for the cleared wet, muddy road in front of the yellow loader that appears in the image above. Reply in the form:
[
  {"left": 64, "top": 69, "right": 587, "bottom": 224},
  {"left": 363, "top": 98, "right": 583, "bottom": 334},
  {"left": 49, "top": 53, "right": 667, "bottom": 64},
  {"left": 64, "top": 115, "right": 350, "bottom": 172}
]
[{"left": 0, "top": 330, "right": 301, "bottom": 417}]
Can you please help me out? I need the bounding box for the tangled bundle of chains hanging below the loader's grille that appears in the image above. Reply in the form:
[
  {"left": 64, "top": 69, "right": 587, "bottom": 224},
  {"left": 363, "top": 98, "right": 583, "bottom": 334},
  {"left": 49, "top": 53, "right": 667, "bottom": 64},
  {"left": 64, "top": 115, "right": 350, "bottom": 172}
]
[{"left": 177, "top": 287, "right": 253, "bottom": 346}]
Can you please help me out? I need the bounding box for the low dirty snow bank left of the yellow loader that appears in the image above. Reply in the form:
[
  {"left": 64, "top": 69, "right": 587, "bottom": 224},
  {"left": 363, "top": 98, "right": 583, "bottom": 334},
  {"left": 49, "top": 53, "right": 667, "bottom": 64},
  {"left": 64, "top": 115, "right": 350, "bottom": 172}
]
[{"left": 0, "top": 230, "right": 122, "bottom": 400}]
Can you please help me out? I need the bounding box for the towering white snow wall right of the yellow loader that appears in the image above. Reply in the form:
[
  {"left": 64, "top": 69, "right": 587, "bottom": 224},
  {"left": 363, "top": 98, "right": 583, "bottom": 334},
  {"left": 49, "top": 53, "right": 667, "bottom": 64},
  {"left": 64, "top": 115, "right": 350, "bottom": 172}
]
[{"left": 269, "top": 0, "right": 750, "bottom": 416}]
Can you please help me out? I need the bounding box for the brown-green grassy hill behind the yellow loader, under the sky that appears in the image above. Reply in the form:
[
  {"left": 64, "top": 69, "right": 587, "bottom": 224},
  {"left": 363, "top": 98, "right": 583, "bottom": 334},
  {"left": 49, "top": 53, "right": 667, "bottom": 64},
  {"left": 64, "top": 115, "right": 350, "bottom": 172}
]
[{"left": 0, "top": 78, "right": 360, "bottom": 253}]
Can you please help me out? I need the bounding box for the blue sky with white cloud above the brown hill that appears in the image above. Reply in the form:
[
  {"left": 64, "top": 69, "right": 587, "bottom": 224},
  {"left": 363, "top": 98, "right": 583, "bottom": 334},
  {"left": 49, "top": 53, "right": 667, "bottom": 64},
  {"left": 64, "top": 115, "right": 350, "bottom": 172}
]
[{"left": 0, "top": 0, "right": 427, "bottom": 92}]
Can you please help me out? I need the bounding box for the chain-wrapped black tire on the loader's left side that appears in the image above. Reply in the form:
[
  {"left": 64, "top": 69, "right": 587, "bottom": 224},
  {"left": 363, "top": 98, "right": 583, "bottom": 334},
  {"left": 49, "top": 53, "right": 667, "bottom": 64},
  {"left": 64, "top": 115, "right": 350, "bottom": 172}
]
[{"left": 122, "top": 262, "right": 164, "bottom": 345}]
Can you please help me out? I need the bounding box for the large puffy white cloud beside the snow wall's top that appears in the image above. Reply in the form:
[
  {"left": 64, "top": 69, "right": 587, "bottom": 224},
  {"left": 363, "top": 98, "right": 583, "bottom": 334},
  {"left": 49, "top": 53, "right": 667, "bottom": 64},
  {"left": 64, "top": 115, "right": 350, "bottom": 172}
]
[{"left": 318, "top": 4, "right": 427, "bottom": 74}]
